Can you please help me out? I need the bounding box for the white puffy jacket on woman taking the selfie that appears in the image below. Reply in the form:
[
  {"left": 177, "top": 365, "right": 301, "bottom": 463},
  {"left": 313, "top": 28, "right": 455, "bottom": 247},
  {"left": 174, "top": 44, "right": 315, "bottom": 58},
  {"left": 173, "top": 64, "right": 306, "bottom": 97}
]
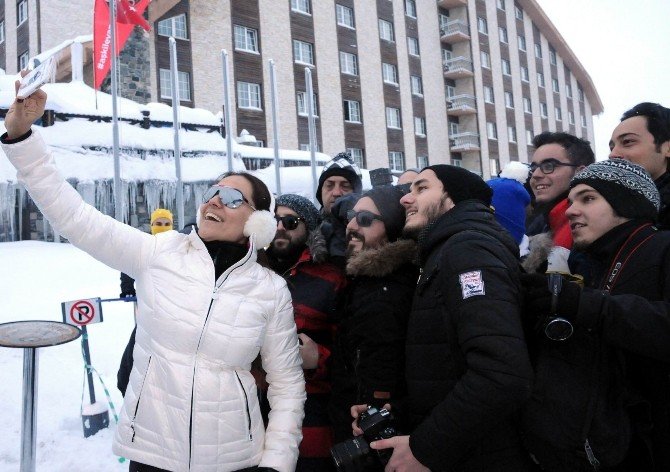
[{"left": 3, "top": 131, "right": 305, "bottom": 472}]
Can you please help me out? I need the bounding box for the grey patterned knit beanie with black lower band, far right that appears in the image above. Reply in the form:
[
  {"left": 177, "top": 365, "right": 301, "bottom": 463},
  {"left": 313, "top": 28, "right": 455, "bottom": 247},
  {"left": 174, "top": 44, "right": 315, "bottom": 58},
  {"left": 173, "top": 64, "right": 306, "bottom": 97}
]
[{"left": 570, "top": 159, "right": 661, "bottom": 221}]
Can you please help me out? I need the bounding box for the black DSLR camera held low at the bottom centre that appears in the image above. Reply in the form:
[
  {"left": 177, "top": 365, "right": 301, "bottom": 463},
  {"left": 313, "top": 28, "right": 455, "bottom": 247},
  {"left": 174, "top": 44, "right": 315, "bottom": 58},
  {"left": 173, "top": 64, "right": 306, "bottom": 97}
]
[{"left": 330, "top": 406, "right": 397, "bottom": 472}]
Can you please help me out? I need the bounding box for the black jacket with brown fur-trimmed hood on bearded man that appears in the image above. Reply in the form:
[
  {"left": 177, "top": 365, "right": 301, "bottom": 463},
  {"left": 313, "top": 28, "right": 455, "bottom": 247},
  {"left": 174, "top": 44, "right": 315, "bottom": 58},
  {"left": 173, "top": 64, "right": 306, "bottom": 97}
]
[{"left": 330, "top": 240, "right": 419, "bottom": 442}]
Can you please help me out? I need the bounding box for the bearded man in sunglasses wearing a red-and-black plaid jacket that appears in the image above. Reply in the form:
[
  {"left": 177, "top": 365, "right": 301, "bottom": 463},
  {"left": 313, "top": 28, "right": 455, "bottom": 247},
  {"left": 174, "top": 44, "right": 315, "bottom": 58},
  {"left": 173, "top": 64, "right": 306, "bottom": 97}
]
[{"left": 267, "top": 194, "right": 346, "bottom": 472}]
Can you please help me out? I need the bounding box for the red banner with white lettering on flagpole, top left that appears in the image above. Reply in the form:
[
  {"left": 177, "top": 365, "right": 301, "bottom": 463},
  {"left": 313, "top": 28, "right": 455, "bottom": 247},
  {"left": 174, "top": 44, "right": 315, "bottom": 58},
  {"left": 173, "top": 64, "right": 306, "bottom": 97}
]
[{"left": 93, "top": 0, "right": 151, "bottom": 89}]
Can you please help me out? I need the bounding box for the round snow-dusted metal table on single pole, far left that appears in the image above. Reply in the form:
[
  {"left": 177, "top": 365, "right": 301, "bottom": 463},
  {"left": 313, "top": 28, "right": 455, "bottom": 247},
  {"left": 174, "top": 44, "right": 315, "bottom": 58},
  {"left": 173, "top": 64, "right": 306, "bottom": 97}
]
[{"left": 0, "top": 320, "right": 81, "bottom": 472}]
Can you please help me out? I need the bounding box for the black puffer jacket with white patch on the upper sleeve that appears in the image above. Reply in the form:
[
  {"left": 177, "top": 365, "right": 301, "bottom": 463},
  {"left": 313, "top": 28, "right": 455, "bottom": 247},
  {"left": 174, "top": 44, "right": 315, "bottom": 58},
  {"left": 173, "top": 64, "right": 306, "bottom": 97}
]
[{"left": 406, "top": 201, "right": 533, "bottom": 472}]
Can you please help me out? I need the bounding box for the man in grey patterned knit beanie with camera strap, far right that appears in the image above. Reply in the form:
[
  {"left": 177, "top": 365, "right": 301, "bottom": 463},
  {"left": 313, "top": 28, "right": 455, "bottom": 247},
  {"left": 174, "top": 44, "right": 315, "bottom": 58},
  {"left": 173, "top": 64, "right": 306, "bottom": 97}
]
[{"left": 522, "top": 159, "right": 670, "bottom": 472}]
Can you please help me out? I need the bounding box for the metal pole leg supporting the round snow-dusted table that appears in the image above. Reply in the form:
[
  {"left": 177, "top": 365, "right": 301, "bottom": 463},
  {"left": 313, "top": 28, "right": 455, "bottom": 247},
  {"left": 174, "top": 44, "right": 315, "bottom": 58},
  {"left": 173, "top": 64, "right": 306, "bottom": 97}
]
[{"left": 19, "top": 347, "right": 38, "bottom": 472}]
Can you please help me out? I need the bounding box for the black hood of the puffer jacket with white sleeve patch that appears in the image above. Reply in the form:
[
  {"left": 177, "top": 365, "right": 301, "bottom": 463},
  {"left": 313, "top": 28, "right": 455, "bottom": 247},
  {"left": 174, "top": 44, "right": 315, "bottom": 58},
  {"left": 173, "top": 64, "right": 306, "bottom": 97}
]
[{"left": 418, "top": 200, "right": 519, "bottom": 264}]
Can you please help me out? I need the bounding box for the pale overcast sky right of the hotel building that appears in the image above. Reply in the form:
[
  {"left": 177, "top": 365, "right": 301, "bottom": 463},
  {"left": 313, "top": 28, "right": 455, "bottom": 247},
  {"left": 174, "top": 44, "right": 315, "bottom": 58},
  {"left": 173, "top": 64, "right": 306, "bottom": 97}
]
[{"left": 537, "top": 0, "right": 670, "bottom": 160}]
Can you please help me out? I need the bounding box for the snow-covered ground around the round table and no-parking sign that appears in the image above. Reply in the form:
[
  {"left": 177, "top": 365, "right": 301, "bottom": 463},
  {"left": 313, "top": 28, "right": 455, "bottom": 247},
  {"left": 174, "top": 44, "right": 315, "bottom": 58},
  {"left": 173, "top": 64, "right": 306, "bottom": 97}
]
[{"left": 0, "top": 241, "right": 134, "bottom": 472}]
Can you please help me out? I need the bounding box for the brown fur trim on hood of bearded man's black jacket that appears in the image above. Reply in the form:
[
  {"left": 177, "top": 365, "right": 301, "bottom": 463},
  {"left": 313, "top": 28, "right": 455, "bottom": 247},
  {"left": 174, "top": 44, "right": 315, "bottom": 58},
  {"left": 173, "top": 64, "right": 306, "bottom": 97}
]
[{"left": 347, "top": 239, "right": 418, "bottom": 277}]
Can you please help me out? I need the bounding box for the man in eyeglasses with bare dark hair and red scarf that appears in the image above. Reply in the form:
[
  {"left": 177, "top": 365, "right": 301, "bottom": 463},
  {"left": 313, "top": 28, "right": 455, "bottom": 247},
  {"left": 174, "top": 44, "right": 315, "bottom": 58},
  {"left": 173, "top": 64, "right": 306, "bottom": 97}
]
[{"left": 523, "top": 131, "right": 595, "bottom": 273}]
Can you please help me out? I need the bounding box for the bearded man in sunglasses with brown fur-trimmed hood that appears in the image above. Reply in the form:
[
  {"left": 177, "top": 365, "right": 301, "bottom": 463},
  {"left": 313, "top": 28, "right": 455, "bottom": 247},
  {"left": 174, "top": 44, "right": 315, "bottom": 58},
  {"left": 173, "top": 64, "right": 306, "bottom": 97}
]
[{"left": 330, "top": 185, "right": 418, "bottom": 442}]
